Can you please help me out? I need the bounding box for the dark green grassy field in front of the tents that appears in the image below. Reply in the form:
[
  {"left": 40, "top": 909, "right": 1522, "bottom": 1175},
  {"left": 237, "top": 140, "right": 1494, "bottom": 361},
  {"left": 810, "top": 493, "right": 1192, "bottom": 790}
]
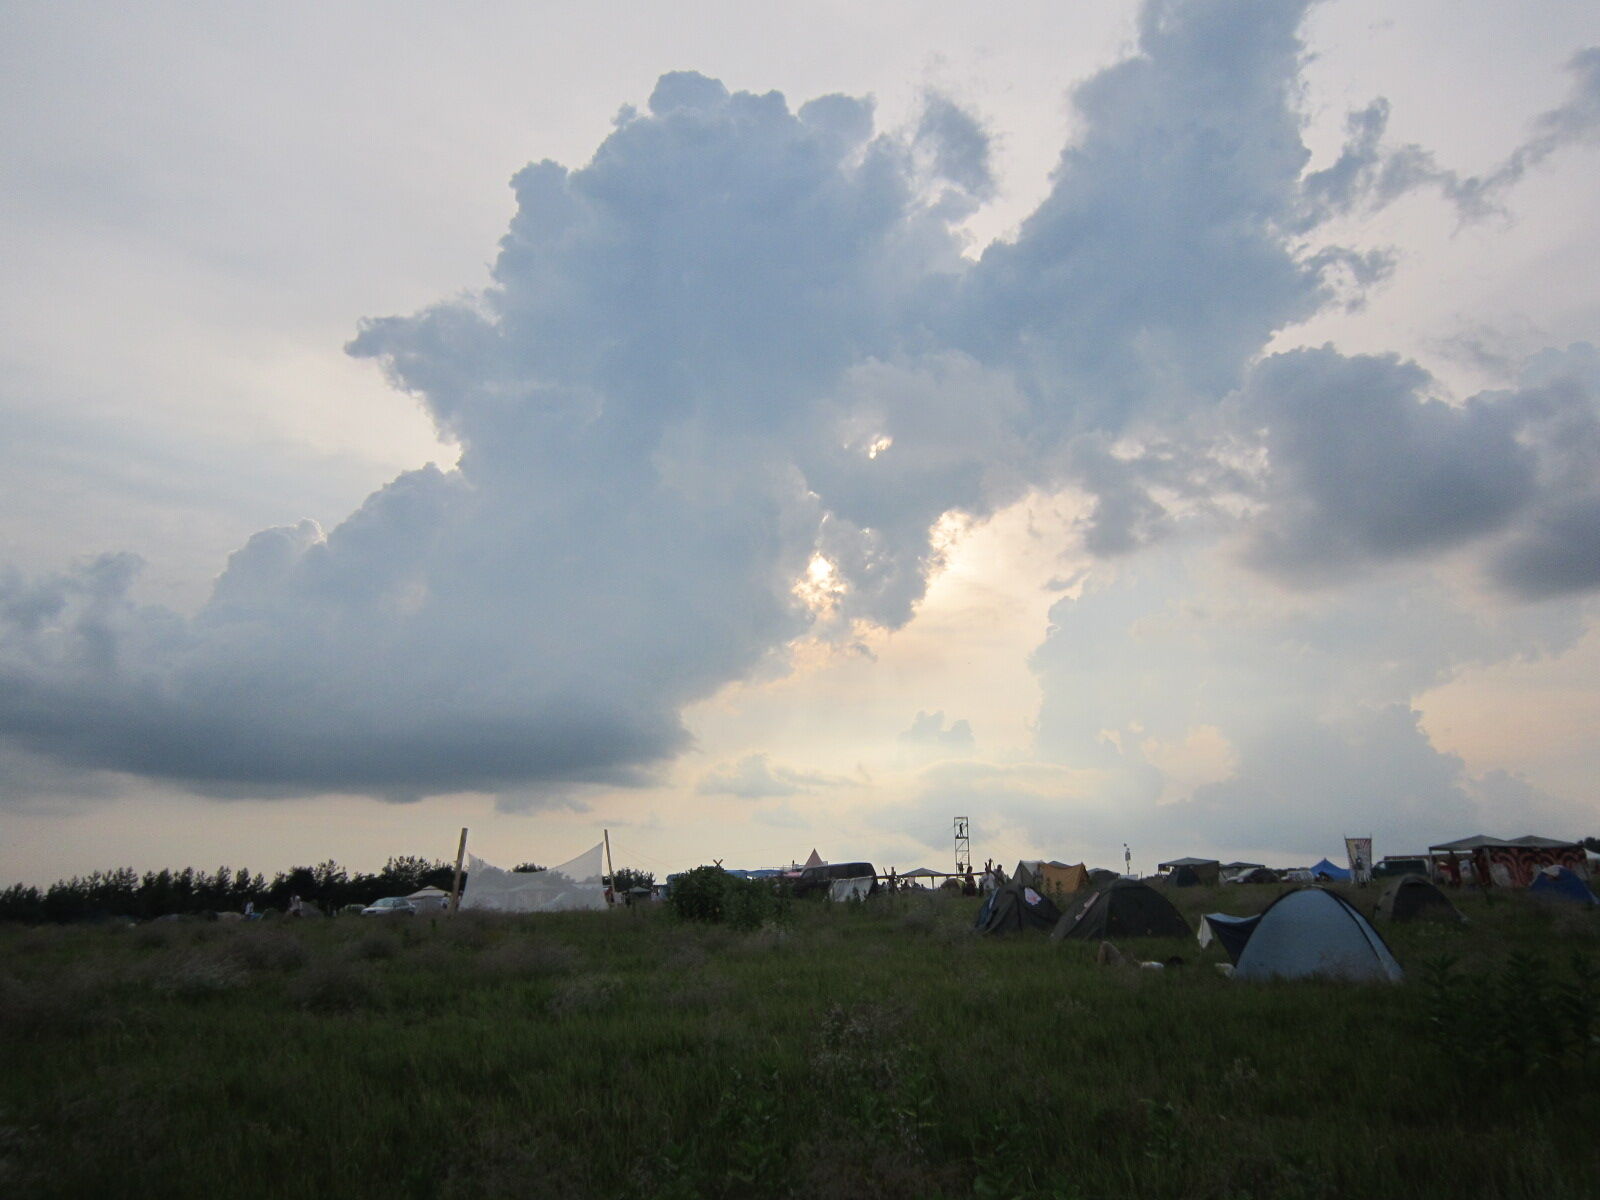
[{"left": 0, "top": 886, "right": 1600, "bottom": 1200}]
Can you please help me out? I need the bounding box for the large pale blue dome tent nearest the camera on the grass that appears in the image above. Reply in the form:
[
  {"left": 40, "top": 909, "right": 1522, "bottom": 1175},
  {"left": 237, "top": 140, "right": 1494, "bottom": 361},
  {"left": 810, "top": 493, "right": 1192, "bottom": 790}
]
[{"left": 1234, "top": 888, "right": 1403, "bottom": 982}]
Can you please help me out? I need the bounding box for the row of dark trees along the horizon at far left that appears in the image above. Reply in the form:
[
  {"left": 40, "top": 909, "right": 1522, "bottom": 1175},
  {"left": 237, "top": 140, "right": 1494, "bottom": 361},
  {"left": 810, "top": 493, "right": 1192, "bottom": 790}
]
[{"left": 0, "top": 854, "right": 454, "bottom": 923}]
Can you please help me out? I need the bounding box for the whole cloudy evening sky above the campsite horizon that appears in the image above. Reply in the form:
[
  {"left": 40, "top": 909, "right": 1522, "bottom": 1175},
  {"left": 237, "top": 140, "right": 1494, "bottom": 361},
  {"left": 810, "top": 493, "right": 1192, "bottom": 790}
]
[{"left": 0, "top": 0, "right": 1600, "bottom": 883}]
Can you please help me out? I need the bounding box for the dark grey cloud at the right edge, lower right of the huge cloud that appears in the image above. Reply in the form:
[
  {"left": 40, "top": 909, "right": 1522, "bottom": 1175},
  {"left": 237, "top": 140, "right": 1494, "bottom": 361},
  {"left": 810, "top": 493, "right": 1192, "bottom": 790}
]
[{"left": 1240, "top": 344, "right": 1600, "bottom": 597}]
